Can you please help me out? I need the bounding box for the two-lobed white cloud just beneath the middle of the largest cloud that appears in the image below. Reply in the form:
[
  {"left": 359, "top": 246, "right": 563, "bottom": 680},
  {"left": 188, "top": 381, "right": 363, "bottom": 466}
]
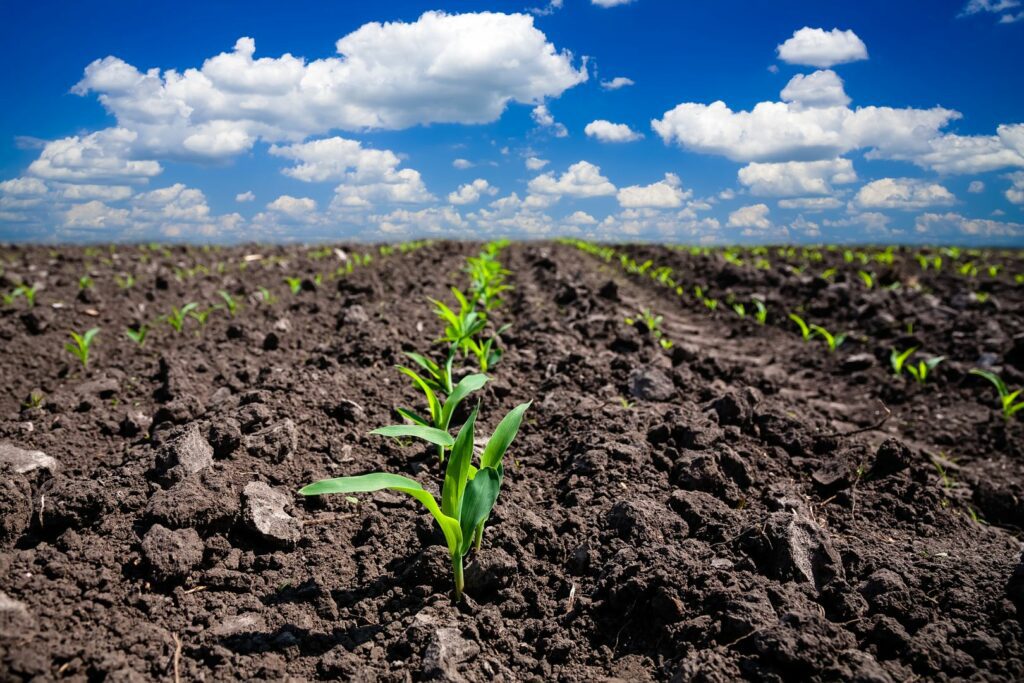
[{"left": 270, "top": 137, "right": 433, "bottom": 207}]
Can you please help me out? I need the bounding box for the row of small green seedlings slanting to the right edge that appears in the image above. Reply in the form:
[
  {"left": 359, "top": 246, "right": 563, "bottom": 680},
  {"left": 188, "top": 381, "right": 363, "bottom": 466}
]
[{"left": 560, "top": 240, "right": 1024, "bottom": 420}]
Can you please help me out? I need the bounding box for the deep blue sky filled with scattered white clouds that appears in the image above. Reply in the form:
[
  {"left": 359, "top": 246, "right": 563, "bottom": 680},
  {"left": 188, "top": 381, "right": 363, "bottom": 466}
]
[{"left": 0, "top": 0, "right": 1024, "bottom": 247}]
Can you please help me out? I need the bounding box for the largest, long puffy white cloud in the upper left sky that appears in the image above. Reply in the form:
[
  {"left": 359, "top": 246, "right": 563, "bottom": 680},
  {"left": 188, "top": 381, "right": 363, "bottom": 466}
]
[{"left": 74, "top": 11, "right": 588, "bottom": 158}]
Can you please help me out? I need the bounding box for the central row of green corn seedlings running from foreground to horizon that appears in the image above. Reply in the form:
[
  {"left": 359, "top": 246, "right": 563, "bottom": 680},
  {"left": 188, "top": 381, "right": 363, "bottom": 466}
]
[{"left": 299, "top": 242, "right": 530, "bottom": 602}]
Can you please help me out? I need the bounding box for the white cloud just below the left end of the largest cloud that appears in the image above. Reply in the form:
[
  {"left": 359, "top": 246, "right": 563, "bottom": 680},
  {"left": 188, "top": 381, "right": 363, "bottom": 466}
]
[{"left": 29, "top": 128, "right": 163, "bottom": 182}]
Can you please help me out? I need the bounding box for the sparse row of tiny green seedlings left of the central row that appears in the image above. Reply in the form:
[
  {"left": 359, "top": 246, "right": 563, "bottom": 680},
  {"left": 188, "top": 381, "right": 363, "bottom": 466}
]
[{"left": 37, "top": 241, "right": 430, "bottom": 370}]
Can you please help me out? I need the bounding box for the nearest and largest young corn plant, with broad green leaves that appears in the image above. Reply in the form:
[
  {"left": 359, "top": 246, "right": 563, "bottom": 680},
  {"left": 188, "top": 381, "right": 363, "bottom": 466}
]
[{"left": 299, "top": 403, "right": 529, "bottom": 602}]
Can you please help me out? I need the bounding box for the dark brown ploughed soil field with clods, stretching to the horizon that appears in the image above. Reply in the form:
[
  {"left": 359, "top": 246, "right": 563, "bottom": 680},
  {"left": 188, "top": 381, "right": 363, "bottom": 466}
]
[{"left": 0, "top": 242, "right": 1024, "bottom": 681}]
